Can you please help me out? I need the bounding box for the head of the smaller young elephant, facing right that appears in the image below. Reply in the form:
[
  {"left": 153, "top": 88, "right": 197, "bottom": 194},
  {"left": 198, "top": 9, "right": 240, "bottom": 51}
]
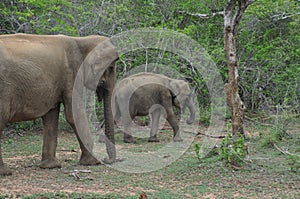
[{"left": 170, "top": 79, "right": 195, "bottom": 124}]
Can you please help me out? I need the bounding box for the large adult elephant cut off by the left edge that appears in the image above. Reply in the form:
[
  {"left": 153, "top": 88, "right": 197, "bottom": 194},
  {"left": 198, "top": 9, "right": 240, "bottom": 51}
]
[{"left": 0, "top": 34, "right": 118, "bottom": 175}]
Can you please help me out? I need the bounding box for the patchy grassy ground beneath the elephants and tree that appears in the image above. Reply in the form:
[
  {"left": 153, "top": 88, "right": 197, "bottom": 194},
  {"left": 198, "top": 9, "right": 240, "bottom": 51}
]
[{"left": 0, "top": 119, "right": 300, "bottom": 199}]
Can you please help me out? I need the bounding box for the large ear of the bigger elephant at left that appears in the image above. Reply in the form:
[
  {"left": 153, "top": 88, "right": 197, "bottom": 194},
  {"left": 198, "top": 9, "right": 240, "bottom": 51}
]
[{"left": 83, "top": 39, "right": 119, "bottom": 90}]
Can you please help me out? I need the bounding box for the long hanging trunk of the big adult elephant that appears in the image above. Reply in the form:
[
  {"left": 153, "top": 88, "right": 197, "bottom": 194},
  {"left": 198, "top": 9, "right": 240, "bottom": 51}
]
[{"left": 103, "top": 69, "right": 116, "bottom": 163}]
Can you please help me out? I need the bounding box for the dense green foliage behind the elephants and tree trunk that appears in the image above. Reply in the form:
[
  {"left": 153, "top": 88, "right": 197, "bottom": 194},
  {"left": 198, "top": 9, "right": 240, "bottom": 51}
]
[{"left": 0, "top": 0, "right": 300, "bottom": 111}]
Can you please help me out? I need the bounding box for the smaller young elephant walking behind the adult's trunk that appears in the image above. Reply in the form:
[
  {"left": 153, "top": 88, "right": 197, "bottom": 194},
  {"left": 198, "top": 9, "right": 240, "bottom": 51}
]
[{"left": 113, "top": 73, "right": 195, "bottom": 143}]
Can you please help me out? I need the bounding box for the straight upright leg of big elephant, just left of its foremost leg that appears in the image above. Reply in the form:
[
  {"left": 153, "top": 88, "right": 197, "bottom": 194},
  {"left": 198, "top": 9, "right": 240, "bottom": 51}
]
[{"left": 40, "top": 105, "right": 61, "bottom": 169}]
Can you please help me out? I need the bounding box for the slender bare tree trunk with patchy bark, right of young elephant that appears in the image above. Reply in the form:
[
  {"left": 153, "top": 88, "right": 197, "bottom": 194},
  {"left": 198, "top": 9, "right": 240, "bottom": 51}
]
[{"left": 224, "top": 0, "right": 253, "bottom": 134}]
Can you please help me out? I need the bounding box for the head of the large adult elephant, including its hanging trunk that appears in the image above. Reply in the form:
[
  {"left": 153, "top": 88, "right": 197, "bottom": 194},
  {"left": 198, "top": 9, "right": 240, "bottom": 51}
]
[{"left": 83, "top": 40, "right": 118, "bottom": 163}]
